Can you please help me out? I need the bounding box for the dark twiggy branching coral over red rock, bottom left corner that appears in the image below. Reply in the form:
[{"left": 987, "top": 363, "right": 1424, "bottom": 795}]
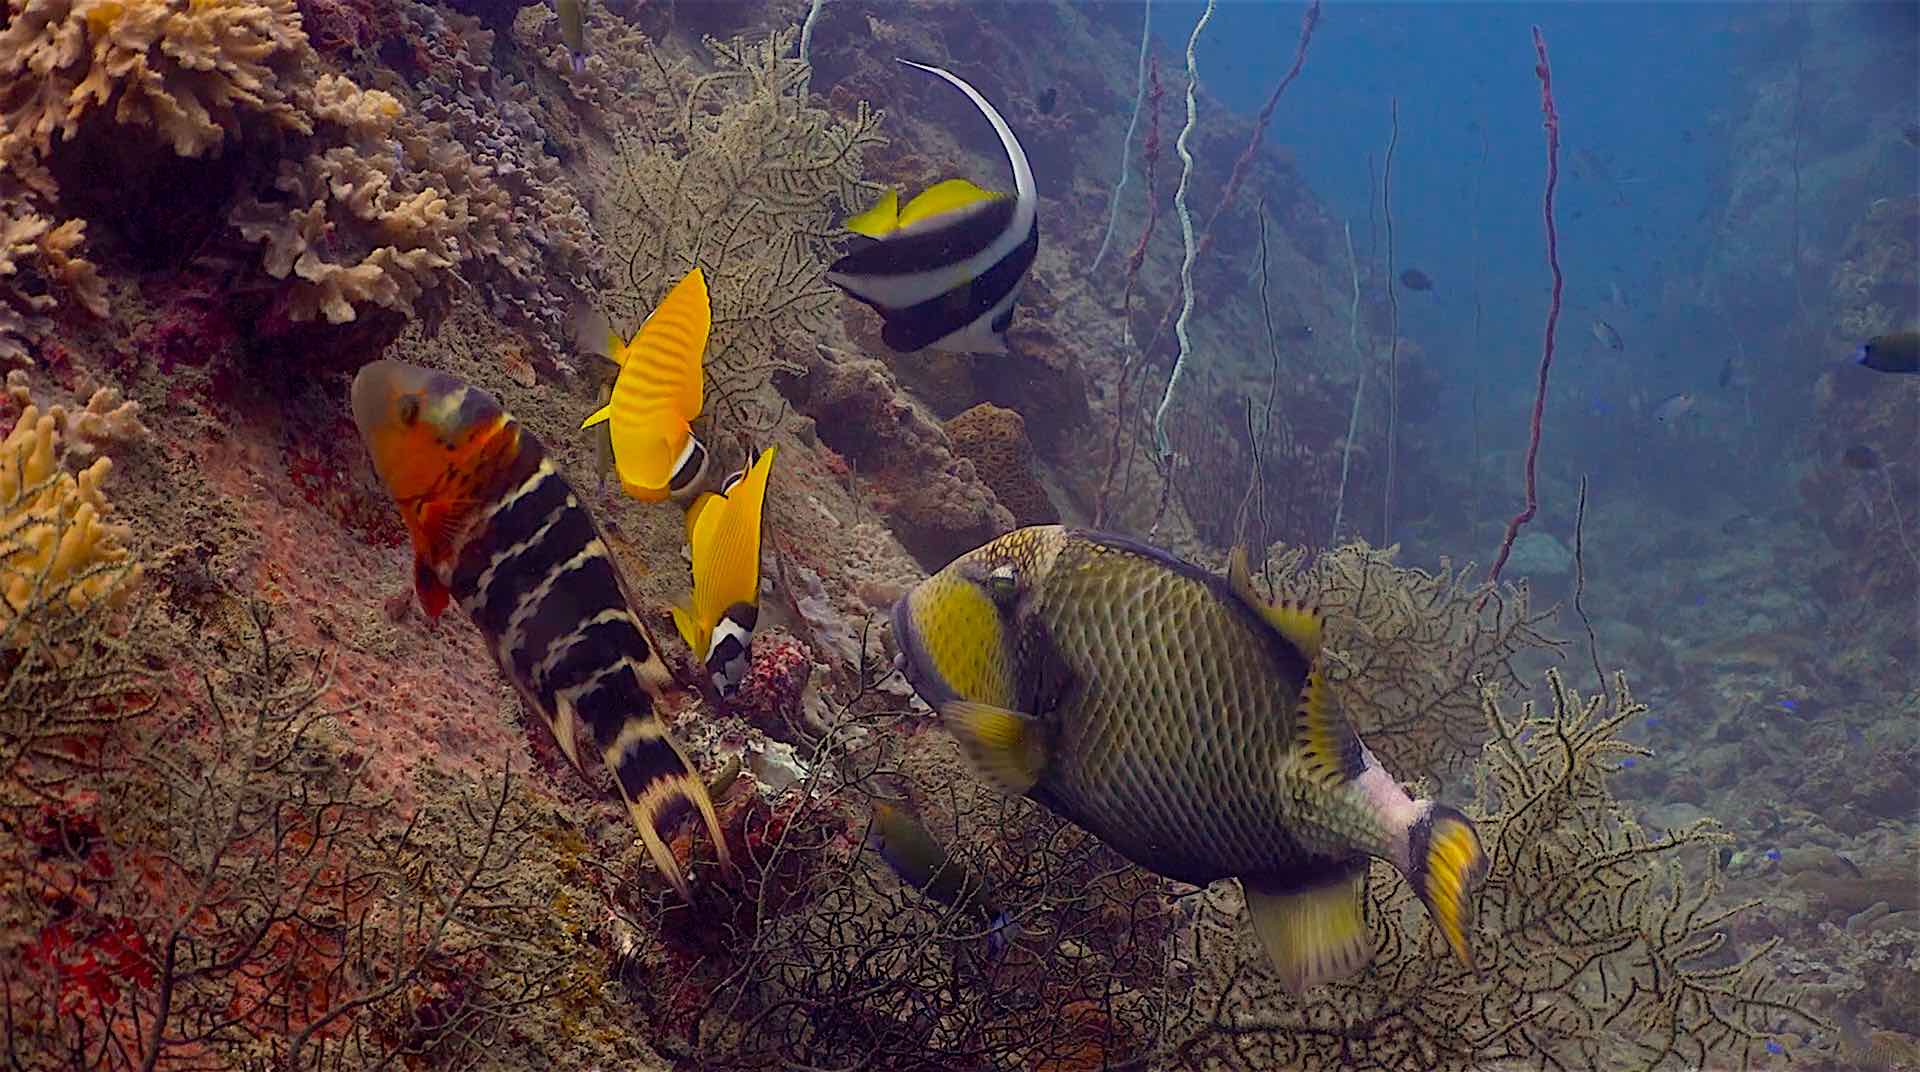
[{"left": 0, "top": 607, "right": 570, "bottom": 1070}]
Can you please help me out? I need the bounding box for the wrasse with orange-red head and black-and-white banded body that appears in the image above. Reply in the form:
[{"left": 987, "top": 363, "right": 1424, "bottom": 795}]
[{"left": 353, "top": 361, "right": 730, "bottom": 899}]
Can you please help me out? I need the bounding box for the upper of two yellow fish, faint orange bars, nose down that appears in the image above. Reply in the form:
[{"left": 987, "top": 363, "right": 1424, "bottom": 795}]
[{"left": 582, "top": 269, "right": 712, "bottom": 499}]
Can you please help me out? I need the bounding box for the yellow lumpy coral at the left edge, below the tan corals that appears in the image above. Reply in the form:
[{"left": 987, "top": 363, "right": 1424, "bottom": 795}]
[{"left": 0, "top": 396, "right": 140, "bottom": 647}]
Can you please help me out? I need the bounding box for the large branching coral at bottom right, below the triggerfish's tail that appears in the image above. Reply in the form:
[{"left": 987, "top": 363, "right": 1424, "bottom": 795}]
[{"left": 1173, "top": 670, "right": 1814, "bottom": 1072}]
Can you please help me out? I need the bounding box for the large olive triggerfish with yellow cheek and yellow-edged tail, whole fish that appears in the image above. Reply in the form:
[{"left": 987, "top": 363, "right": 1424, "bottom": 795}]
[{"left": 893, "top": 524, "right": 1486, "bottom": 991}]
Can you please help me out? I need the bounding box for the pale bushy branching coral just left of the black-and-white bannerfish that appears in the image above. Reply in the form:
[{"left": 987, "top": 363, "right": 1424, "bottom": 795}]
[{"left": 603, "top": 31, "right": 881, "bottom": 426}]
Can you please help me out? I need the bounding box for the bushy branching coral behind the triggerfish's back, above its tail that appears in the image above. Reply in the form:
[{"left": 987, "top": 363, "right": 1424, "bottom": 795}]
[{"left": 1267, "top": 542, "right": 1561, "bottom": 780}]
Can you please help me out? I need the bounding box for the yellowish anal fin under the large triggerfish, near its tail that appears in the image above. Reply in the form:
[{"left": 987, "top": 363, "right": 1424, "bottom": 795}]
[{"left": 1240, "top": 859, "right": 1373, "bottom": 993}]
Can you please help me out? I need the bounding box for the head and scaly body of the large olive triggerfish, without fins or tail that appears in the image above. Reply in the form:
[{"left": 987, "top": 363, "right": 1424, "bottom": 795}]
[{"left": 897, "top": 526, "right": 1390, "bottom": 884}]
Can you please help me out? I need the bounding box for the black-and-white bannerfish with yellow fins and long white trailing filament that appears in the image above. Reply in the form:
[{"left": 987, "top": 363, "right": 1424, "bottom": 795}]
[{"left": 828, "top": 60, "right": 1041, "bottom": 353}]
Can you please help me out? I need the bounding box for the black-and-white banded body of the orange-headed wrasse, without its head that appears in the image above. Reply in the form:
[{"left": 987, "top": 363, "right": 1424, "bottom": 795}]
[{"left": 436, "top": 388, "right": 728, "bottom": 897}]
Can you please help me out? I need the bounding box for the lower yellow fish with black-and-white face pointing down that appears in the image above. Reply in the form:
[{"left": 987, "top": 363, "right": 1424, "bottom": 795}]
[{"left": 674, "top": 448, "right": 776, "bottom": 695}]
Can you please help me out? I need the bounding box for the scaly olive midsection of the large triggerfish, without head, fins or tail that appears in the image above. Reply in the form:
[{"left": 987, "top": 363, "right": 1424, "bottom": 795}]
[{"left": 1035, "top": 538, "right": 1336, "bottom": 884}]
